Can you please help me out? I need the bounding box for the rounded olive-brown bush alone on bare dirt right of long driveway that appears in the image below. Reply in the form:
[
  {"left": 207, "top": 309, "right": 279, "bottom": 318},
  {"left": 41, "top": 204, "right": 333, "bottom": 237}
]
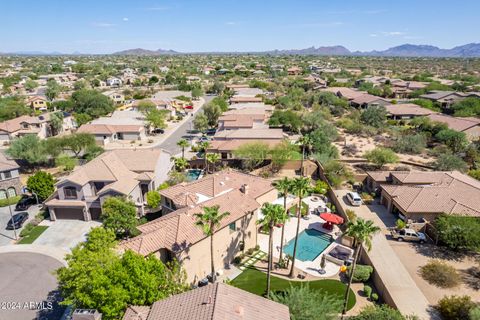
[{"left": 420, "top": 260, "right": 460, "bottom": 288}]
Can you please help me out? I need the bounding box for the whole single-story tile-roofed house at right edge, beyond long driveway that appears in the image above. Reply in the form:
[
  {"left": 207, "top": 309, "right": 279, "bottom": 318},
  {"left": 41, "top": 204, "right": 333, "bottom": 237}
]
[{"left": 365, "top": 171, "right": 480, "bottom": 221}]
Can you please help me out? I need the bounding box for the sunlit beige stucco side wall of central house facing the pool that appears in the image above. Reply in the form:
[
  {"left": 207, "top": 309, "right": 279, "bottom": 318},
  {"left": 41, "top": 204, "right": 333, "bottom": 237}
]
[{"left": 177, "top": 213, "right": 257, "bottom": 284}]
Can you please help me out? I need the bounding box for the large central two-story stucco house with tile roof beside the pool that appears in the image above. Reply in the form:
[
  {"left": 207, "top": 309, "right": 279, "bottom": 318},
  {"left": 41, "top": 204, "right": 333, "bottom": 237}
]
[{"left": 120, "top": 170, "right": 277, "bottom": 283}]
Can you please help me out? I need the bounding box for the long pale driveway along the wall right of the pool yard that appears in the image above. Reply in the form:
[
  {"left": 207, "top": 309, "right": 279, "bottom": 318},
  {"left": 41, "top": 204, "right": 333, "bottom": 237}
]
[{"left": 335, "top": 190, "right": 433, "bottom": 319}]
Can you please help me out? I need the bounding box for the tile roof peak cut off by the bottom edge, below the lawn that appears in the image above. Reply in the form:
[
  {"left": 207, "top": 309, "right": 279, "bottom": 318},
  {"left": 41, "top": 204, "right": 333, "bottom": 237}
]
[{"left": 123, "top": 282, "right": 290, "bottom": 320}]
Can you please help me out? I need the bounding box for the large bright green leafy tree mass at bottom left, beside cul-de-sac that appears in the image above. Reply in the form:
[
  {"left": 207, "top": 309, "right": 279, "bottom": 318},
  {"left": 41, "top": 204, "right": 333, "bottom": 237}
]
[{"left": 57, "top": 228, "right": 188, "bottom": 320}]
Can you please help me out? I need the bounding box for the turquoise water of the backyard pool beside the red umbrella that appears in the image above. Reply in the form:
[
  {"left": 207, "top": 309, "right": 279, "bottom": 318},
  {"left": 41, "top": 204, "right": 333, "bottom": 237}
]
[{"left": 284, "top": 229, "right": 333, "bottom": 261}]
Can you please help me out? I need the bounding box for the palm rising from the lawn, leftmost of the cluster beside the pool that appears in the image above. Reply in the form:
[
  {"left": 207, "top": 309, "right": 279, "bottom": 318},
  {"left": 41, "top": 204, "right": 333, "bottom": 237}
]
[{"left": 257, "top": 202, "right": 287, "bottom": 297}]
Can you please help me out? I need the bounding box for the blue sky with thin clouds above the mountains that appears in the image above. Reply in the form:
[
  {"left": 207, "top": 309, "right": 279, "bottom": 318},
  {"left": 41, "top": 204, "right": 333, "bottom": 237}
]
[{"left": 0, "top": 0, "right": 480, "bottom": 53}]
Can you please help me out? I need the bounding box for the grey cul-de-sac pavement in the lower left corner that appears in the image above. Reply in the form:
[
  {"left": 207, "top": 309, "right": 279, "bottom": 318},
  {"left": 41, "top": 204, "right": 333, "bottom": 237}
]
[{"left": 0, "top": 252, "right": 64, "bottom": 320}]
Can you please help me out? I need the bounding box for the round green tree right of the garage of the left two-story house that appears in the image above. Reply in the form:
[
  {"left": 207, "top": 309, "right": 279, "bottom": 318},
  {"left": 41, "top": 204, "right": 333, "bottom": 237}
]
[{"left": 101, "top": 197, "right": 138, "bottom": 238}]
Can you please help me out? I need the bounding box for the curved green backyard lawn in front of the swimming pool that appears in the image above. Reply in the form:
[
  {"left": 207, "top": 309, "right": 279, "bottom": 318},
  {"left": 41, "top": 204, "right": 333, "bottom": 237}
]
[{"left": 231, "top": 268, "right": 357, "bottom": 310}]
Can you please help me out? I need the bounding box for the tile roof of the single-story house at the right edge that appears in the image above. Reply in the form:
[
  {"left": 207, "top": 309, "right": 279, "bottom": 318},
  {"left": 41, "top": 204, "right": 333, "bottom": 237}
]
[{"left": 382, "top": 171, "right": 480, "bottom": 217}]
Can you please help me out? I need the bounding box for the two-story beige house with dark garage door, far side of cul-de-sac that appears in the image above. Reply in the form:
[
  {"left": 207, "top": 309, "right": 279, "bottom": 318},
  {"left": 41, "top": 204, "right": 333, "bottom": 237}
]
[{"left": 45, "top": 149, "right": 173, "bottom": 221}]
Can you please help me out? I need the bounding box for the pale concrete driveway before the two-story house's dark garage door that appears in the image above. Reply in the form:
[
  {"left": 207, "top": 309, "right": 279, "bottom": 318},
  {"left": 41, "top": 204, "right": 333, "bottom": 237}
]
[{"left": 34, "top": 220, "right": 101, "bottom": 251}]
